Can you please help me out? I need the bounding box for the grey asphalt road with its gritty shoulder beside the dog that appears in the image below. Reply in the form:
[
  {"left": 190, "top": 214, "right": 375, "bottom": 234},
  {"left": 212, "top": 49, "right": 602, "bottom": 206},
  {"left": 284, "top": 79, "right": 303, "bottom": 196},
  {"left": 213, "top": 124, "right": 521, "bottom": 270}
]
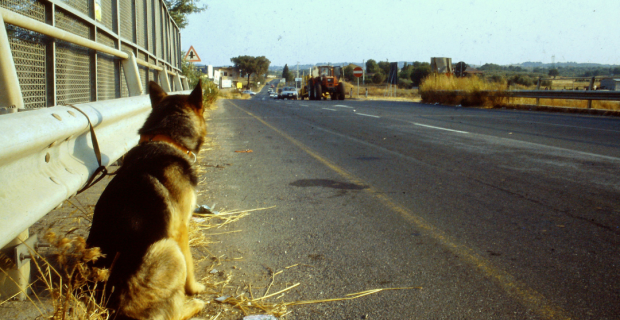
[{"left": 199, "top": 84, "right": 620, "bottom": 319}]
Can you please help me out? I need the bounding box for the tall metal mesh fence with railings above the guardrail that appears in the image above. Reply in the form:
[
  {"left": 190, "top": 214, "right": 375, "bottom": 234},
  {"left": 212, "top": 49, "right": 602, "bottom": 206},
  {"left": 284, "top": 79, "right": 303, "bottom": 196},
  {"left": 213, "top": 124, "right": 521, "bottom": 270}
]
[{"left": 0, "top": 0, "right": 181, "bottom": 108}]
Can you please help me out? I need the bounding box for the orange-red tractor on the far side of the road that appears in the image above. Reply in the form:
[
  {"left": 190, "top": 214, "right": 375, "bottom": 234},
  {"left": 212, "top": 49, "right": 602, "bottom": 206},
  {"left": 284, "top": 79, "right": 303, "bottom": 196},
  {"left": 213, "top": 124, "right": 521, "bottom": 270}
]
[{"left": 299, "top": 66, "right": 345, "bottom": 100}]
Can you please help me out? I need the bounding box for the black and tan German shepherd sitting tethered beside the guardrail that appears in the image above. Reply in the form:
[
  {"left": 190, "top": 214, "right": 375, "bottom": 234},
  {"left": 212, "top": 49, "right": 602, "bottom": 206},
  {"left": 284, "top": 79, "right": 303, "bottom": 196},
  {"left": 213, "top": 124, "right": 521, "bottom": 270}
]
[{"left": 86, "top": 82, "right": 207, "bottom": 319}]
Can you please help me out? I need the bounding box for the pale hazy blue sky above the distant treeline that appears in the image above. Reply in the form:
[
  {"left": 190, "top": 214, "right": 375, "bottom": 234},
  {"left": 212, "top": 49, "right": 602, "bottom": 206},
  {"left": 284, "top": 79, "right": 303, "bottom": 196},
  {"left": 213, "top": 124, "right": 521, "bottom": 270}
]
[{"left": 181, "top": 0, "right": 620, "bottom": 66}]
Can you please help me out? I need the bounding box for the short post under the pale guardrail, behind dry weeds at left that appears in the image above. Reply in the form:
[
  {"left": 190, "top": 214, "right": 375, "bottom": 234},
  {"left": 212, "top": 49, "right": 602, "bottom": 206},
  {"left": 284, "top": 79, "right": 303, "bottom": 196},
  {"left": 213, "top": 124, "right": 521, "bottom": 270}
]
[{"left": 0, "top": 230, "right": 30, "bottom": 301}]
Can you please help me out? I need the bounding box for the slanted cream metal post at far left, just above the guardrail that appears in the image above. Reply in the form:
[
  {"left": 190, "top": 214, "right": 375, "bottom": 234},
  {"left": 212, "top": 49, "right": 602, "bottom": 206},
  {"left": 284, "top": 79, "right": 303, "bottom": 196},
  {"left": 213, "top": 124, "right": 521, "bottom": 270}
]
[{"left": 0, "top": 14, "right": 24, "bottom": 112}]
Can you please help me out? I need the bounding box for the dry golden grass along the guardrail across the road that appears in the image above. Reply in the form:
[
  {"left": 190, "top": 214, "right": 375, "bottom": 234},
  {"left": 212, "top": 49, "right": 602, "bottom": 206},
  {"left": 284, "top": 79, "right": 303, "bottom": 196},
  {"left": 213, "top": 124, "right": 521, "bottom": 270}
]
[{"left": 420, "top": 75, "right": 620, "bottom": 110}]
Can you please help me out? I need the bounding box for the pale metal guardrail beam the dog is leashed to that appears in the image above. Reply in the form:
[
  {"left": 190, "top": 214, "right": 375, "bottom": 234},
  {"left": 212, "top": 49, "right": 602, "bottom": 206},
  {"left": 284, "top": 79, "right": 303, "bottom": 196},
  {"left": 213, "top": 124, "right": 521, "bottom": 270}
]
[{"left": 0, "top": 91, "right": 189, "bottom": 248}]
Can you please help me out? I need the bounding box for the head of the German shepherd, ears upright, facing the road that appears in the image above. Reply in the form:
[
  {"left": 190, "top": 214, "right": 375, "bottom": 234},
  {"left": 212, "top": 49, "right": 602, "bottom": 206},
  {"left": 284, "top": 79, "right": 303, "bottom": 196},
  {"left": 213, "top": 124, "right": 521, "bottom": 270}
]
[{"left": 138, "top": 81, "right": 207, "bottom": 154}]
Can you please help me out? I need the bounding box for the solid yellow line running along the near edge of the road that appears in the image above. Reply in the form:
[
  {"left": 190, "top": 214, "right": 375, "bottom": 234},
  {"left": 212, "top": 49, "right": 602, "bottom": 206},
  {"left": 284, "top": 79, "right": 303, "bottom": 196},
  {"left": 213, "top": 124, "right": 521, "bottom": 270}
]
[{"left": 228, "top": 100, "right": 571, "bottom": 320}]
